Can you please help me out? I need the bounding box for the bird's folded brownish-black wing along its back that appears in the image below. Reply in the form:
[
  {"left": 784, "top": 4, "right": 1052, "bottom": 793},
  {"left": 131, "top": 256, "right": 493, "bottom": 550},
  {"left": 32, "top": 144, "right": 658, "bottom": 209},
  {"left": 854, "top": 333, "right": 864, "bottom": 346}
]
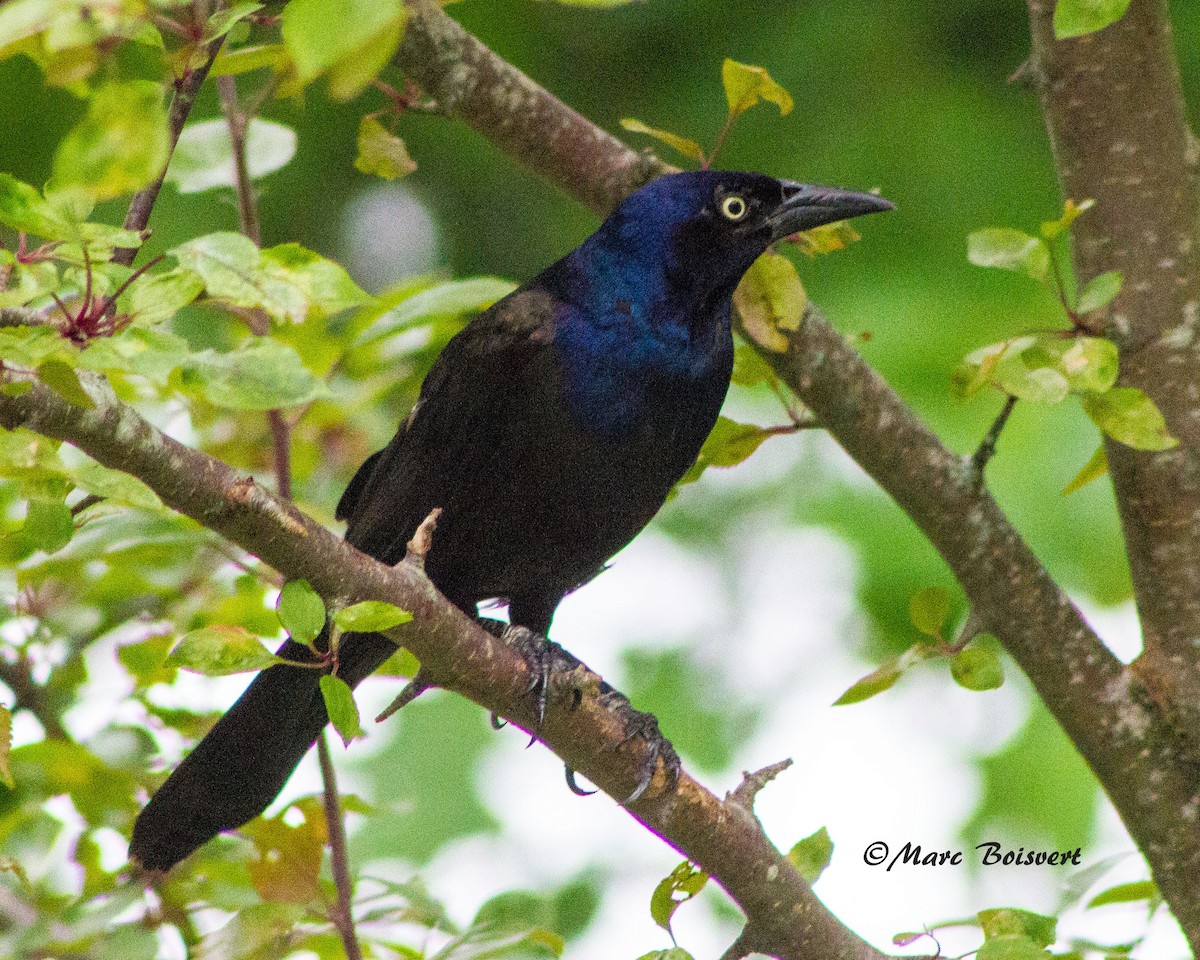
[{"left": 337, "top": 288, "right": 558, "bottom": 571}]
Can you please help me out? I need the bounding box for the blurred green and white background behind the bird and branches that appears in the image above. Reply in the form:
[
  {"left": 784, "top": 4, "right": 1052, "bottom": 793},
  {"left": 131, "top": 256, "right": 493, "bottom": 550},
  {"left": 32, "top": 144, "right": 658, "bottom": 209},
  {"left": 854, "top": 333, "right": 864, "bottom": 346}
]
[{"left": 0, "top": 0, "right": 1200, "bottom": 958}]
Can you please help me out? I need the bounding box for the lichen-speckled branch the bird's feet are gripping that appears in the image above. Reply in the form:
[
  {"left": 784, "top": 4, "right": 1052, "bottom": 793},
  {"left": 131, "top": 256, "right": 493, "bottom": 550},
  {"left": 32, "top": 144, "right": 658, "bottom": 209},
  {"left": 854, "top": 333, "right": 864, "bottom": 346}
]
[{"left": 0, "top": 370, "right": 883, "bottom": 960}]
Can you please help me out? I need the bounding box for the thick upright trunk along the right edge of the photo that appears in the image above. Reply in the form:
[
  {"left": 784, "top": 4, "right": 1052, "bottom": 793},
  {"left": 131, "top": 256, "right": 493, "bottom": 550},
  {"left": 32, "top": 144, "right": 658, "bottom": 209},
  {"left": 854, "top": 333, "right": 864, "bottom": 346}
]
[{"left": 1030, "top": 0, "right": 1200, "bottom": 754}]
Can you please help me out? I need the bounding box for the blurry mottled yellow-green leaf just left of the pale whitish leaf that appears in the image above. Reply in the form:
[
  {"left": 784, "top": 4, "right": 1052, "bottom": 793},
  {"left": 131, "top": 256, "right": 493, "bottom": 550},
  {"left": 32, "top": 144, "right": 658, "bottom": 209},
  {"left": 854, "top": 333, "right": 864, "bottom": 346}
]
[{"left": 50, "top": 80, "right": 170, "bottom": 200}]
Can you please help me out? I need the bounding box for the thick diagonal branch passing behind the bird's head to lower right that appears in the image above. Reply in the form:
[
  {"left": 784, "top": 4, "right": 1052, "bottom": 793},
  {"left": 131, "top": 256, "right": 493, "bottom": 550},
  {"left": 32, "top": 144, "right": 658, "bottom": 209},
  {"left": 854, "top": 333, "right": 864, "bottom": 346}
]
[{"left": 397, "top": 0, "right": 1200, "bottom": 947}]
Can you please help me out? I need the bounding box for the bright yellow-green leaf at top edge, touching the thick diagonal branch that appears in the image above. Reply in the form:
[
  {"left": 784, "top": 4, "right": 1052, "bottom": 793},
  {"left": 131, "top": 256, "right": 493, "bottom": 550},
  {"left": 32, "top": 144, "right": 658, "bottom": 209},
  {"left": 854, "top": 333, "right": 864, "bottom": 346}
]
[{"left": 282, "top": 0, "right": 406, "bottom": 83}]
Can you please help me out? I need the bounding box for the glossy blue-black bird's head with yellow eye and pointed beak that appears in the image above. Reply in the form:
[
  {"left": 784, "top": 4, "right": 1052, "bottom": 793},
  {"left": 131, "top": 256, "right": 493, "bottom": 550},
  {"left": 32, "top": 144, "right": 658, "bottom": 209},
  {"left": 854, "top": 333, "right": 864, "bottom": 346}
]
[{"left": 598, "top": 170, "right": 893, "bottom": 292}]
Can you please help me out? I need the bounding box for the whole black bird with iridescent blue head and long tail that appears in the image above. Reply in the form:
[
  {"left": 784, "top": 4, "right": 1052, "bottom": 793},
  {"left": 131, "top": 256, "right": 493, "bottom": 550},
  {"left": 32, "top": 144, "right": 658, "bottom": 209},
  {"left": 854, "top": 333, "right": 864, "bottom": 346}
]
[{"left": 130, "top": 170, "right": 892, "bottom": 870}]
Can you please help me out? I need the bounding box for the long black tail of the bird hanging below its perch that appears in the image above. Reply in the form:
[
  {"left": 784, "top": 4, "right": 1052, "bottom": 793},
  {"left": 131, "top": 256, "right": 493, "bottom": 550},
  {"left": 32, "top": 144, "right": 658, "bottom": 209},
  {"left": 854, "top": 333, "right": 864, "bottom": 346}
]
[{"left": 130, "top": 634, "right": 396, "bottom": 870}]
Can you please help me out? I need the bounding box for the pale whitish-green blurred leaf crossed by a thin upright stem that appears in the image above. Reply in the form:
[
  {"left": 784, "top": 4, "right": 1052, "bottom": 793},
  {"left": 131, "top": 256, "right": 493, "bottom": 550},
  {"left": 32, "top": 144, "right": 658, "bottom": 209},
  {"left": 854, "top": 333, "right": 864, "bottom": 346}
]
[{"left": 167, "top": 116, "right": 296, "bottom": 193}]
